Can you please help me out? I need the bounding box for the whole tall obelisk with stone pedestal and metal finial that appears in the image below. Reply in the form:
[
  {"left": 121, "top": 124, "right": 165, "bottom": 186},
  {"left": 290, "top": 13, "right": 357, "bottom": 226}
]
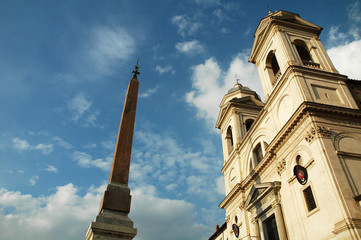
[{"left": 85, "top": 62, "right": 139, "bottom": 240}]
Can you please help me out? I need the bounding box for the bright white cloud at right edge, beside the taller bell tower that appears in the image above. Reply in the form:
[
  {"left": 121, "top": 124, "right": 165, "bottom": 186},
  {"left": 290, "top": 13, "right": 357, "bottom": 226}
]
[{"left": 327, "top": 40, "right": 361, "bottom": 79}]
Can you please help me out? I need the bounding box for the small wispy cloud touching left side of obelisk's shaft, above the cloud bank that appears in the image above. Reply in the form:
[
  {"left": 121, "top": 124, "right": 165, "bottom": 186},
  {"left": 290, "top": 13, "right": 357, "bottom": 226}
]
[{"left": 72, "top": 151, "right": 113, "bottom": 171}]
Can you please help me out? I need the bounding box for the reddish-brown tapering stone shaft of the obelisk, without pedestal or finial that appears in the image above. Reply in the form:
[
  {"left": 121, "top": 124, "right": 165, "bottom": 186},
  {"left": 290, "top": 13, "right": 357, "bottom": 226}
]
[{"left": 109, "top": 77, "right": 139, "bottom": 184}]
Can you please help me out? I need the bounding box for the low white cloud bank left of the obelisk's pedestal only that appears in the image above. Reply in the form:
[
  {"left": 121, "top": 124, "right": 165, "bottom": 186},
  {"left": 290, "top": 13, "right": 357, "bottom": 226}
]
[{"left": 0, "top": 183, "right": 105, "bottom": 240}]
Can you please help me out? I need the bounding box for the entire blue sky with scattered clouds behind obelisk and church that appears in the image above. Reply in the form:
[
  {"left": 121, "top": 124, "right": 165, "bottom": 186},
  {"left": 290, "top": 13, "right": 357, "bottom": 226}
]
[{"left": 0, "top": 0, "right": 361, "bottom": 240}]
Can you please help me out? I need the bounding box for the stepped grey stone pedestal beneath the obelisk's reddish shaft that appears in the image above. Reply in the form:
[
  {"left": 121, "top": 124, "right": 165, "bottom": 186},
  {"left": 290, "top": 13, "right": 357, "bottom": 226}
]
[{"left": 85, "top": 183, "right": 137, "bottom": 240}]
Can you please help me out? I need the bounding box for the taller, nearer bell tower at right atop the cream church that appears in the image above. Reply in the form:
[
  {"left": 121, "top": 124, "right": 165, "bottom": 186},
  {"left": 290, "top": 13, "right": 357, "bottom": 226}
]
[{"left": 249, "top": 11, "right": 358, "bottom": 124}]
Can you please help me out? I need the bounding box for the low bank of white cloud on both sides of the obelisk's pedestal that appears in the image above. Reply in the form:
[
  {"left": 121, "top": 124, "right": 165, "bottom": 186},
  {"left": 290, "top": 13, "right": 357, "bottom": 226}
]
[{"left": 0, "top": 183, "right": 212, "bottom": 240}]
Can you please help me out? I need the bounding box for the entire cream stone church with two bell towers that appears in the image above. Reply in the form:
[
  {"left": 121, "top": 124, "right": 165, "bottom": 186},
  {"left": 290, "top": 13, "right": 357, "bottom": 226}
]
[{"left": 209, "top": 11, "right": 361, "bottom": 240}]
